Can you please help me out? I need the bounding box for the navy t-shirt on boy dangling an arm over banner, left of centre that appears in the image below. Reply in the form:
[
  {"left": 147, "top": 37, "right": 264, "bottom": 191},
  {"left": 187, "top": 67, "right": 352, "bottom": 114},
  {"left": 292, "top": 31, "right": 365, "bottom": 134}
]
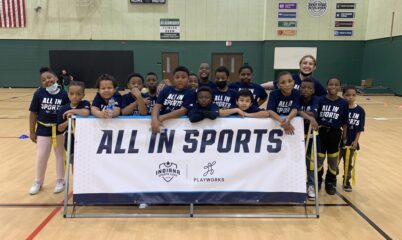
[{"left": 156, "top": 86, "right": 196, "bottom": 115}]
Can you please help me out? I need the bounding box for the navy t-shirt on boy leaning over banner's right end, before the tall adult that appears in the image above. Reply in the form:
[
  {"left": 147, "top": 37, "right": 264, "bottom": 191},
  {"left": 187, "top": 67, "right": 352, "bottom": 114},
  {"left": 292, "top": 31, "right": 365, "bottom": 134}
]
[{"left": 267, "top": 89, "right": 300, "bottom": 115}]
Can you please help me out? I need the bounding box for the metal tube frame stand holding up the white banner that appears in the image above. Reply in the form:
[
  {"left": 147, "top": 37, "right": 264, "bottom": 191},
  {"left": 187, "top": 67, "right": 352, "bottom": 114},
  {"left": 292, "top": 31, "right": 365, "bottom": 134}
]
[{"left": 63, "top": 116, "right": 320, "bottom": 218}]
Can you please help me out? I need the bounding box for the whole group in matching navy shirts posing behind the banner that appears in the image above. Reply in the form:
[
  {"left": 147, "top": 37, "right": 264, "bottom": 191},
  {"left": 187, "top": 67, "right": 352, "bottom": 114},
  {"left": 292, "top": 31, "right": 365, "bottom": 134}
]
[{"left": 29, "top": 56, "right": 364, "bottom": 202}]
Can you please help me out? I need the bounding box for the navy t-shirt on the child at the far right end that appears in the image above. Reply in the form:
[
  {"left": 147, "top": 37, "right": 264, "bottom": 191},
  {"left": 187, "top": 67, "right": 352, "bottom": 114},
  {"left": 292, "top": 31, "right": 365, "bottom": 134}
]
[{"left": 346, "top": 105, "right": 366, "bottom": 149}]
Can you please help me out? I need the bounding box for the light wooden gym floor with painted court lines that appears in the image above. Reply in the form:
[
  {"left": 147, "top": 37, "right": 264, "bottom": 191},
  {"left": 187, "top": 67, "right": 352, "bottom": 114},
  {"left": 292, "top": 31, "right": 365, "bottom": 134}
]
[{"left": 0, "top": 89, "right": 402, "bottom": 240}]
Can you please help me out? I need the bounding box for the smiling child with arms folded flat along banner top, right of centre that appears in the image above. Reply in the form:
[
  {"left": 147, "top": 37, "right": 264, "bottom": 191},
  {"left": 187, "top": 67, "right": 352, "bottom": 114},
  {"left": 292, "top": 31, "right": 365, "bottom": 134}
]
[{"left": 219, "top": 90, "right": 269, "bottom": 118}]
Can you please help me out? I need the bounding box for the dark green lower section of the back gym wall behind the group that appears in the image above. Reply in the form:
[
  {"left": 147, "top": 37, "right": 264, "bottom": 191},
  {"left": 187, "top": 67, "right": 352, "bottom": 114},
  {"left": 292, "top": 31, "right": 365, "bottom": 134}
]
[{"left": 0, "top": 40, "right": 364, "bottom": 87}]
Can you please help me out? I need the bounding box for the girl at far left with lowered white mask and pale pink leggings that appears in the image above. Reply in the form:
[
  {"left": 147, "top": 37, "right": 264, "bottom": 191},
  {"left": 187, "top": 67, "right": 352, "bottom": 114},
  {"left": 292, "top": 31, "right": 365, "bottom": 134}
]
[{"left": 29, "top": 68, "right": 69, "bottom": 195}]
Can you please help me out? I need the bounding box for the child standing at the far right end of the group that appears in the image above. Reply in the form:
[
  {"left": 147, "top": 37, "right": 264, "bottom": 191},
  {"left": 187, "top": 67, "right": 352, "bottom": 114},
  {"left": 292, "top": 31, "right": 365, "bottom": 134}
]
[{"left": 341, "top": 86, "right": 366, "bottom": 192}]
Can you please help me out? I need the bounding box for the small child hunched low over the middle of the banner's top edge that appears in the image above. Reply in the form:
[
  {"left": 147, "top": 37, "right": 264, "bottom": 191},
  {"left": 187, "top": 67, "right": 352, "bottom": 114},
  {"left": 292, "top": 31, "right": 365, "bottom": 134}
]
[{"left": 188, "top": 87, "right": 219, "bottom": 122}]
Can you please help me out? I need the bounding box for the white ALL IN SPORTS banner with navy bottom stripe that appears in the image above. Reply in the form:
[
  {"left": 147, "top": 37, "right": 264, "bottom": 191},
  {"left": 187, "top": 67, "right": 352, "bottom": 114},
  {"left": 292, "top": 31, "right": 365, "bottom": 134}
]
[{"left": 73, "top": 117, "right": 306, "bottom": 204}]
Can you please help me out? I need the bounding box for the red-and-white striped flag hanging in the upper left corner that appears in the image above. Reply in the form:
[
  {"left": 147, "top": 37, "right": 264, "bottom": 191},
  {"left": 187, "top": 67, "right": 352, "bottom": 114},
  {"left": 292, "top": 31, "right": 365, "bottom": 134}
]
[{"left": 0, "top": 0, "right": 26, "bottom": 28}]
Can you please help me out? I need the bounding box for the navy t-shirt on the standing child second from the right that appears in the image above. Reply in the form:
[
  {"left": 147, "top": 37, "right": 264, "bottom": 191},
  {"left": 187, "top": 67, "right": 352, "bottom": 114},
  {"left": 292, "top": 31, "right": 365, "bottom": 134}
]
[{"left": 317, "top": 96, "right": 348, "bottom": 129}]
